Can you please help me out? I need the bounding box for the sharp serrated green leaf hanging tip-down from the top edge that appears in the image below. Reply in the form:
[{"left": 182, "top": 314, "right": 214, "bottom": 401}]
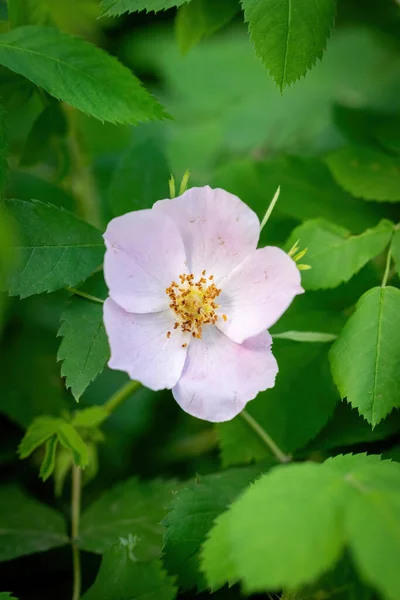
[{"left": 242, "top": 0, "right": 336, "bottom": 91}]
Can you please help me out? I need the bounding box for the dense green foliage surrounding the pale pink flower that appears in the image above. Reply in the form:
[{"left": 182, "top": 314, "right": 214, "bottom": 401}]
[{"left": 0, "top": 0, "right": 400, "bottom": 600}]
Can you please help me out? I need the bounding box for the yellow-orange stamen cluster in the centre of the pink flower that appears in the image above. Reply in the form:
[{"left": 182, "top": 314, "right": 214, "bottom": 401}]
[{"left": 165, "top": 271, "right": 227, "bottom": 346}]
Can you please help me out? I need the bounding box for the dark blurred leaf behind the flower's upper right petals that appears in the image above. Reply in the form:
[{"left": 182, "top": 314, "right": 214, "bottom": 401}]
[{"left": 250, "top": 157, "right": 380, "bottom": 233}]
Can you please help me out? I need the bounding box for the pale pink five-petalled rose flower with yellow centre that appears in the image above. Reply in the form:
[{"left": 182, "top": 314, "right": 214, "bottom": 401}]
[{"left": 104, "top": 186, "right": 303, "bottom": 422}]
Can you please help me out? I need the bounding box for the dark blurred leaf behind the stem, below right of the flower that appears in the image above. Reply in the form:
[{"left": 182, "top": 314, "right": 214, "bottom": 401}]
[{"left": 217, "top": 340, "right": 339, "bottom": 467}]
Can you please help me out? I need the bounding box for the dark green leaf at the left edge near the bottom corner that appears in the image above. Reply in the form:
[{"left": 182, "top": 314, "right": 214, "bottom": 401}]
[{"left": 0, "top": 485, "right": 68, "bottom": 560}]
